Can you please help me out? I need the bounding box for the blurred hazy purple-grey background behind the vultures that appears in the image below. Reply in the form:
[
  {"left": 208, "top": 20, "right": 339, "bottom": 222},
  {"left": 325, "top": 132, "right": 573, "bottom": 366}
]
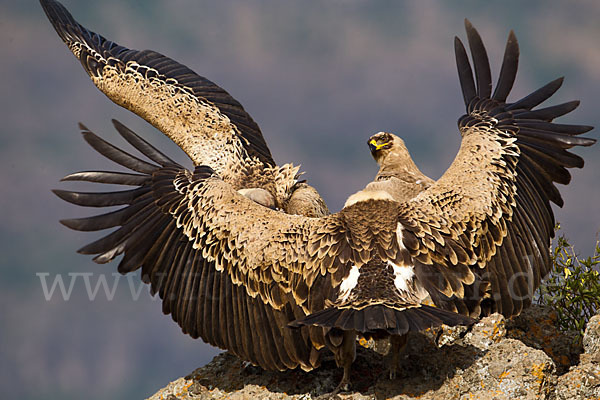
[{"left": 0, "top": 0, "right": 600, "bottom": 399}]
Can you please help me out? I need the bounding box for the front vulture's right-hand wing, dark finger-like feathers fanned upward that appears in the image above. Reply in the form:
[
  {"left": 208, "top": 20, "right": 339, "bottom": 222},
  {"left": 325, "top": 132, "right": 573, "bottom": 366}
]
[{"left": 400, "top": 21, "right": 595, "bottom": 316}]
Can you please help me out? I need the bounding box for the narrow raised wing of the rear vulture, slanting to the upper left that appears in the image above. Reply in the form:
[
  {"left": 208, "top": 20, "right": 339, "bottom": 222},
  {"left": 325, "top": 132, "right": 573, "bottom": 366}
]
[{"left": 40, "top": 0, "right": 275, "bottom": 179}]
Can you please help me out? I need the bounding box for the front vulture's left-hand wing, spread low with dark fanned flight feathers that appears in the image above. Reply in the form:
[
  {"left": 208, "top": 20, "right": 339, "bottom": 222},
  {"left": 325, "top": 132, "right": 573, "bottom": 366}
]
[{"left": 54, "top": 121, "right": 326, "bottom": 370}]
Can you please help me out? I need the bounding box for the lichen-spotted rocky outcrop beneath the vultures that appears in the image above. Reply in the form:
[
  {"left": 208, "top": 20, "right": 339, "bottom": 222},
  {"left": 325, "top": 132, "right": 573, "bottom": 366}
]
[{"left": 150, "top": 307, "right": 600, "bottom": 400}]
